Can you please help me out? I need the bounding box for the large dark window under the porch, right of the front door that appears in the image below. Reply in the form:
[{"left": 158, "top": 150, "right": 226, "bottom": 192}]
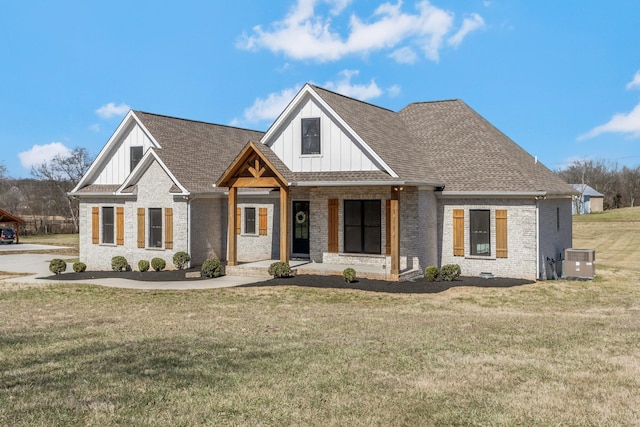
[{"left": 344, "top": 200, "right": 382, "bottom": 254}]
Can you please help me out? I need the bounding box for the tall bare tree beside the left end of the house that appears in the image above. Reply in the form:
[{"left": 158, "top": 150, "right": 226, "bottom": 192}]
[{"left": 31, "top": 147, "right": 92, "bottom": 232}]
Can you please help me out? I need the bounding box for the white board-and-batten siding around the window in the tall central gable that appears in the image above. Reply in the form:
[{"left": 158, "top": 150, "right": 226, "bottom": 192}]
[{"left": 266, "top": 98, "right": 383, "bottom": 172}]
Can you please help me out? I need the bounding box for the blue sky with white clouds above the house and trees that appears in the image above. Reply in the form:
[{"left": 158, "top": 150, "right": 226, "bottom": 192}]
[{"left": 0, "top": 0, "right": 640, "bottom": 178}]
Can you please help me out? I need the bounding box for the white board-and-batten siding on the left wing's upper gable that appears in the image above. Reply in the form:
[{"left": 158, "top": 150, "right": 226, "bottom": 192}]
[{"left": 93, "top": 123, "right": 153, "bottom": 185}]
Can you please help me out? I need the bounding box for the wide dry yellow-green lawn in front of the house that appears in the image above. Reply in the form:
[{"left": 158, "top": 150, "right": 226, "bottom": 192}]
[{"left": 0, "top": 218, "right": 640, "bottom": 426}]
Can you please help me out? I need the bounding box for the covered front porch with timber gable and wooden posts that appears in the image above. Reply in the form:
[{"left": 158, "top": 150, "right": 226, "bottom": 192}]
[{"left": 216, "top": 142, "right": 402, "bottom": 281}]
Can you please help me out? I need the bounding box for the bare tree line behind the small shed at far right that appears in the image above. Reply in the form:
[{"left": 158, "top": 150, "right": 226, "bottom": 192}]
[{"left": 556, "top": 160, "right": 640, "bottom": 210}]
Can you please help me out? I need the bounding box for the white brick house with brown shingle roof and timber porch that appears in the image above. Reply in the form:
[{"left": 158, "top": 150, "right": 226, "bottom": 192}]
[{"left": 70, "top": 84, "right": 575, "bottom": 280}]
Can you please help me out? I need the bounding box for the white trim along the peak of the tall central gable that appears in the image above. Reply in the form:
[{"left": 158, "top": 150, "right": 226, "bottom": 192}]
[{"left": 260, "top": 84, "right": 399, "bottom": 178}]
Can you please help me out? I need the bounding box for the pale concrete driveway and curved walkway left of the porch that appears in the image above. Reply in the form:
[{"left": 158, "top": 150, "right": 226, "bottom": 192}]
[{"left": 0, "top": 254, "right": 264, "bottom": 290}]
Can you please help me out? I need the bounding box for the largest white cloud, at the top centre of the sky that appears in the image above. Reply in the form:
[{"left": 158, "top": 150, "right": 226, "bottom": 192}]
[{"left": 238, "top": 0, "right": 484, "bottom": 63}]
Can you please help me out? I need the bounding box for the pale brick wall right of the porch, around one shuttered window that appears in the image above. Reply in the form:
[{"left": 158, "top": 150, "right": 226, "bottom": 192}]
[{"left": 438, "top": 198, "right": 540, "bottom": 280}]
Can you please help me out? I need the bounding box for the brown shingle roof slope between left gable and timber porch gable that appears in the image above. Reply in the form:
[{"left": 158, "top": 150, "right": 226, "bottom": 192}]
[{"left": 135, "top": 111, "right": 263, "bottom": 193}]
